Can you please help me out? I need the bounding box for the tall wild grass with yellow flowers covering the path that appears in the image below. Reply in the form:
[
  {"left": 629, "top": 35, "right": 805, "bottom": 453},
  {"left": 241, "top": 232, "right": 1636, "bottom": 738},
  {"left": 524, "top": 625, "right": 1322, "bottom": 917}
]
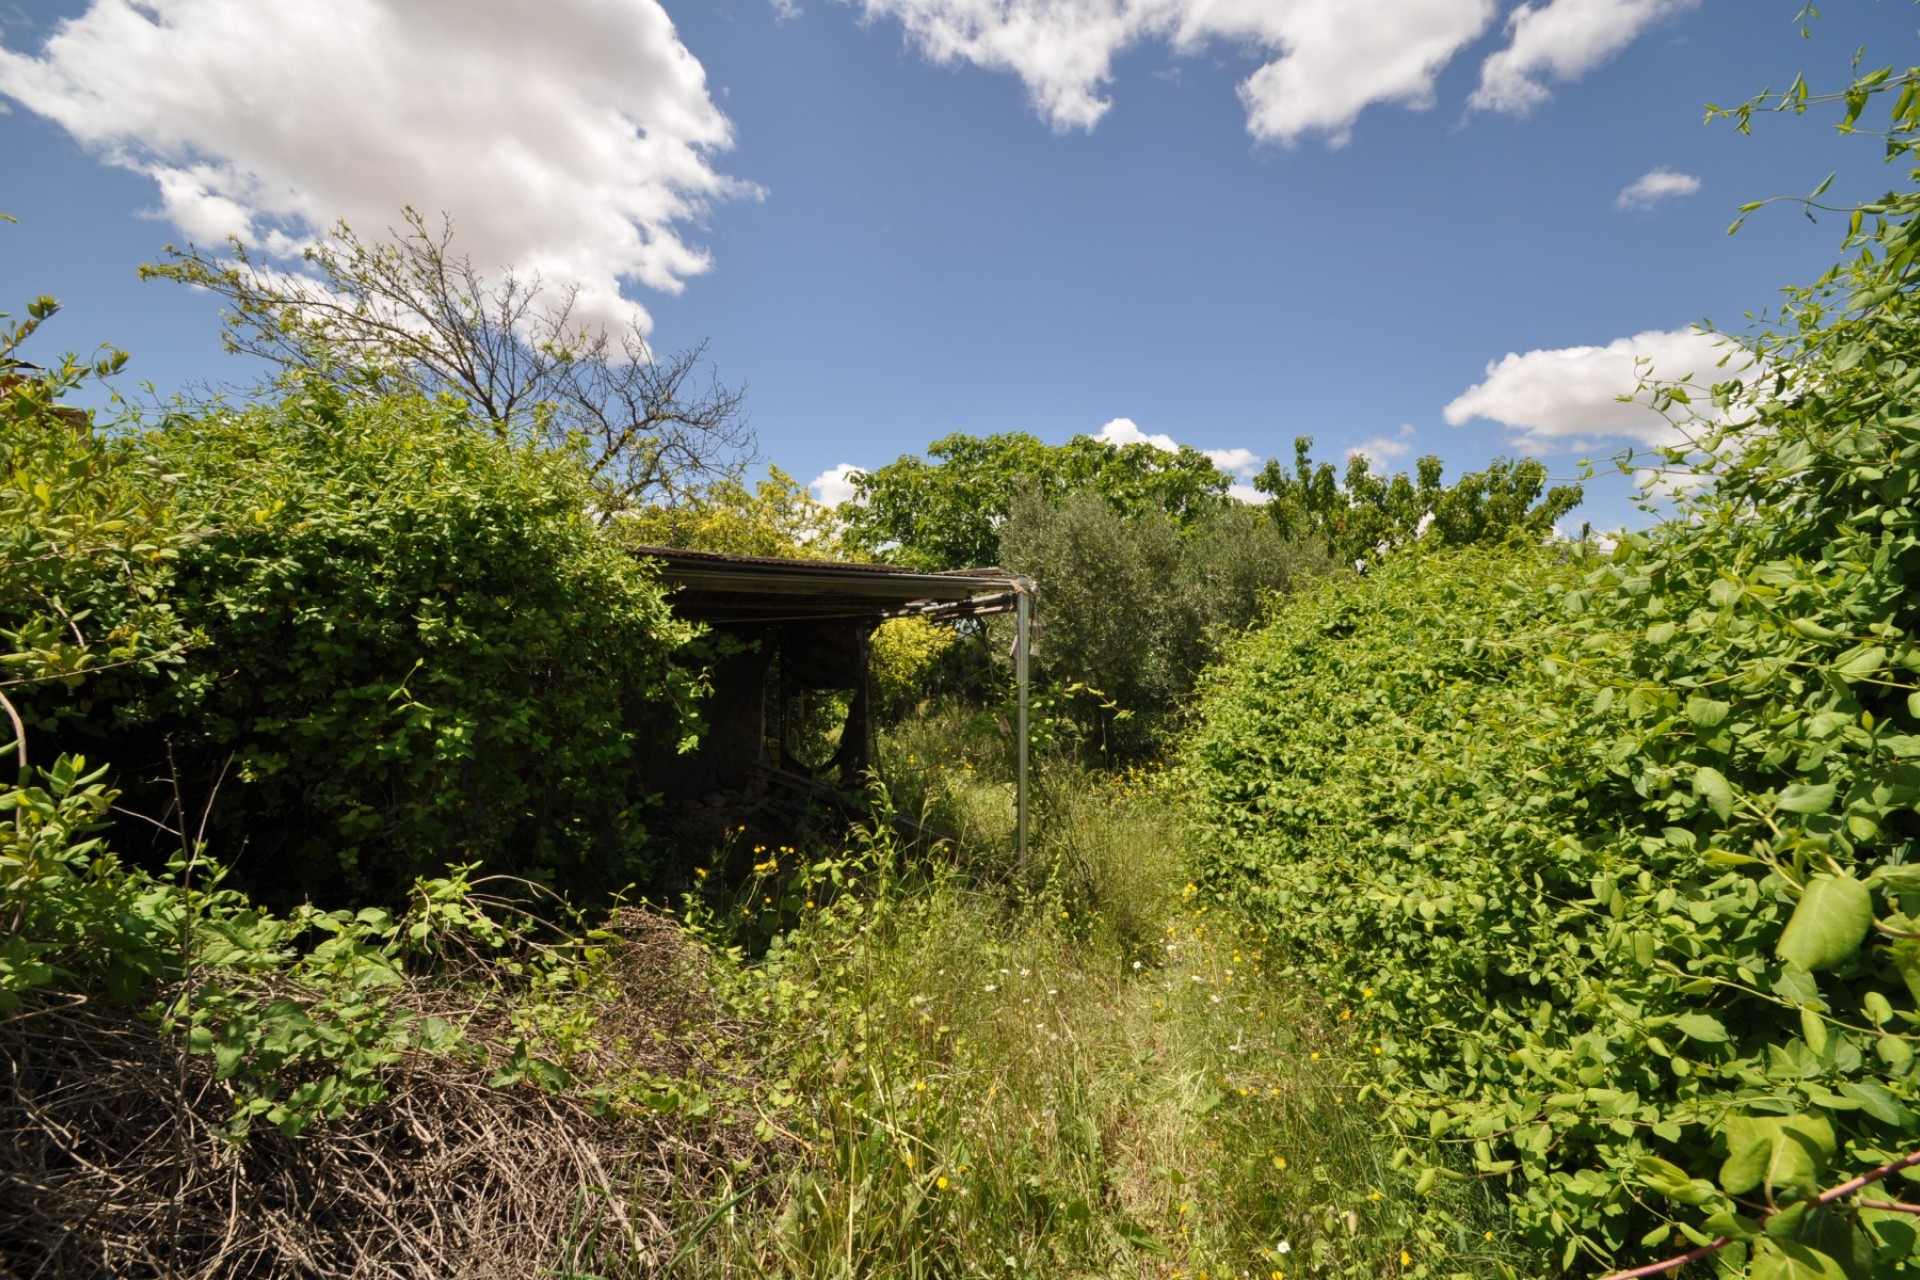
[{"left": 664, "top": 731, "right": 1526, "bottom": 1280}]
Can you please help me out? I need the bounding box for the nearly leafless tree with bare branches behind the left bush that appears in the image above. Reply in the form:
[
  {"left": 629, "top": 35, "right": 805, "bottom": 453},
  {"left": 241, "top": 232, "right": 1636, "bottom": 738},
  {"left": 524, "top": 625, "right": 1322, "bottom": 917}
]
[{"left": 140, "top": 207, "right": 755, "bottom": 516}]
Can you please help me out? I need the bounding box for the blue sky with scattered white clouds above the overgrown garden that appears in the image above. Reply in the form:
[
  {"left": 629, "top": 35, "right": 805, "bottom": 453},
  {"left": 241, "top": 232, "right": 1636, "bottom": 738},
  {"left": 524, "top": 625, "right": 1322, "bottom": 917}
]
[{"left": 0, "top": 0, "right": 1920, "bottom": 526}]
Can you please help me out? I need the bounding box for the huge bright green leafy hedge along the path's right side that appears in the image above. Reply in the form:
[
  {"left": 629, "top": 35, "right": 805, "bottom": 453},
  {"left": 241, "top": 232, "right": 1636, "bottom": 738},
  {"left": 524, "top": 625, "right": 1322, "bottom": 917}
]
[{"left": 1187, "top": 180, "right": 1920, "bottom": 1276}]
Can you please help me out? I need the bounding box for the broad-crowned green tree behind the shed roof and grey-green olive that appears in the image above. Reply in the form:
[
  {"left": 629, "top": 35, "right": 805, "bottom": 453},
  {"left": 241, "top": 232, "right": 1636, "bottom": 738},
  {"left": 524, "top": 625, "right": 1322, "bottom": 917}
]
[{"left": 839, "top": 432, "right": 1229, "bottom": 570}]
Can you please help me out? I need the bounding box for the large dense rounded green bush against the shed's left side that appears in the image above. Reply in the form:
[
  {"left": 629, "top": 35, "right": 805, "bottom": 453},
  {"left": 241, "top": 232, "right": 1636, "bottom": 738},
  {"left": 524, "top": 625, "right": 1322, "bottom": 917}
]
[{"left": 88, "top": 382, "right": 691, "bottom": 896}]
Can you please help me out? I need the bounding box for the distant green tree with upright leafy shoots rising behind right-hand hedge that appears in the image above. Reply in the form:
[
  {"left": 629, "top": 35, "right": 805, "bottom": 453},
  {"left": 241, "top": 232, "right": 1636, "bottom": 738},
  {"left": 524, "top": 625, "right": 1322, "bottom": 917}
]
[{"left": 1254, "top": 436, "right": 1580, "bottom": 562}]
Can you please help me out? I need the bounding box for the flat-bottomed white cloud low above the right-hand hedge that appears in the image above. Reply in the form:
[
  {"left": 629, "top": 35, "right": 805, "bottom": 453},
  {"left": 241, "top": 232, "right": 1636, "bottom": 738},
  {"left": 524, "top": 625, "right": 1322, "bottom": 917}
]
[{"left": 1444, "top": 328, "right": 1755, "bottom": 453}]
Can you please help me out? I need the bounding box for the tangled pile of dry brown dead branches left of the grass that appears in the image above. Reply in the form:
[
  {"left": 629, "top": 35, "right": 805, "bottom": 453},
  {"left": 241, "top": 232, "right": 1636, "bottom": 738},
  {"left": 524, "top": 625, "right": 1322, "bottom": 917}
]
[{"left": 0, "top": 913, "right": 776, "bottom": 1280}]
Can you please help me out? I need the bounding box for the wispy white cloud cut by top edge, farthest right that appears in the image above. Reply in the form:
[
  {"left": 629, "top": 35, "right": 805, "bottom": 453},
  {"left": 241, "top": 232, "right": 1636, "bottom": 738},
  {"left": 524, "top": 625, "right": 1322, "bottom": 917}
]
[{"left": 1469, "top": 0, "right": 1699, "bottom": 115}]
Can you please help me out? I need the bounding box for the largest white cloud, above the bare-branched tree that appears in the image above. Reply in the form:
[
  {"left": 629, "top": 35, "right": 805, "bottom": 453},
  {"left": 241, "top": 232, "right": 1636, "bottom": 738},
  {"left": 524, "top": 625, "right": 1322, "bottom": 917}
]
[{"left": 0, "top": 0, "right": 755, "bottom": 335}]
